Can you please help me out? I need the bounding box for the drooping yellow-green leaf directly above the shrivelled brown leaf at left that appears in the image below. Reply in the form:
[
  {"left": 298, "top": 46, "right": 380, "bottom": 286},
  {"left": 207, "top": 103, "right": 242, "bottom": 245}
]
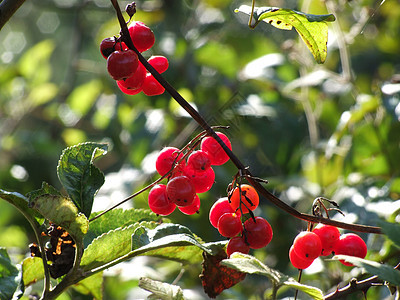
[{"left": 29, "top": 194, "right": 89, "bottom": 243}]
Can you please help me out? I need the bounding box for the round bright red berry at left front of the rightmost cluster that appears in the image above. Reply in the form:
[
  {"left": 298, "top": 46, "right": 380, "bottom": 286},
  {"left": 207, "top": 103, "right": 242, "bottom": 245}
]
[{"left": 293, "top": 231, "right": 322, "bottom": 259}]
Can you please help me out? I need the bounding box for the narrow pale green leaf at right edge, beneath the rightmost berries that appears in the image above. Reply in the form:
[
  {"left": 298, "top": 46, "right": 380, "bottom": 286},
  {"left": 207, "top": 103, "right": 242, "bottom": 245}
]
[{"left": 333, "top": 255, "right": 400, "bottom": 285}]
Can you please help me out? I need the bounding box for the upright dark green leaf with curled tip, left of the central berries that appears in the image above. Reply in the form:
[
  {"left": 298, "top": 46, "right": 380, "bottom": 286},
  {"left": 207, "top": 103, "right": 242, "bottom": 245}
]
[{"left": 57, "top": 143, "right": 108, "bottom": 217}]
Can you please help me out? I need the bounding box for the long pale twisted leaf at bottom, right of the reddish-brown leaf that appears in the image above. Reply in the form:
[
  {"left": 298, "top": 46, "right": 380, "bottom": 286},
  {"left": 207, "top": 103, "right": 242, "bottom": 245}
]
[{"left": 221, "top": 253, "right": 323, "bottom": 300}]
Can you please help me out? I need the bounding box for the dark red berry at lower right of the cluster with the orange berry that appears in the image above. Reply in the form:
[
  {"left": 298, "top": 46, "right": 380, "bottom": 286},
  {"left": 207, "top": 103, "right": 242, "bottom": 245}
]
[{"left": 243, "top": 217, "right": 273, "bottom": 249}]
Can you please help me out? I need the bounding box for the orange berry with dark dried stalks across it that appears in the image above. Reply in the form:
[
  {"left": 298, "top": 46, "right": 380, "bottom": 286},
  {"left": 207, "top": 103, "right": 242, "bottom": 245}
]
[{"left": 230, "top": 184, "right": 260, "bottom": 214}]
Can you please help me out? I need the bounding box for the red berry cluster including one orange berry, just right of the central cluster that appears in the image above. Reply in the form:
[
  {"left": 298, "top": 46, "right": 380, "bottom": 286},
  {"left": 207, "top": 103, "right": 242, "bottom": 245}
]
[{"left": 209, "top": 184, "right": 273, "bottom": 256}]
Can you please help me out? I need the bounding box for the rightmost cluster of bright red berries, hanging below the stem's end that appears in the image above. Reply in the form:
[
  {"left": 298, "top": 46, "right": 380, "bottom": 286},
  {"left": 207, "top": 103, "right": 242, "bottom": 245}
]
[{"left": 289, "top": 224, "right": 367, "bottom": 269}]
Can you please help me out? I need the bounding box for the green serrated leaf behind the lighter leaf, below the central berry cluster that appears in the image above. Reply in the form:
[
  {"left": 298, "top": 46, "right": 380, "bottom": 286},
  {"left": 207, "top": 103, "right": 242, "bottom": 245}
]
[{"left": 84, "top": 208, "right": 161, "bottom": 245}]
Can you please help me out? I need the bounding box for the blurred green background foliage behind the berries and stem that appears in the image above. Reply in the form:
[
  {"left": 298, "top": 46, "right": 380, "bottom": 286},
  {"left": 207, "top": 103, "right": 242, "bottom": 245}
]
[{"left": 0, "top": 0, "right": 400, "bottom": 299}]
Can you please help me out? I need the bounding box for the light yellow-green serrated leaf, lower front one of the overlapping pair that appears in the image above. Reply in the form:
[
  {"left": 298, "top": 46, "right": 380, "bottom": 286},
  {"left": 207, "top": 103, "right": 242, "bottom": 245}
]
[{"left": 81, "top": 221, "right": 158, "bottom": 271}]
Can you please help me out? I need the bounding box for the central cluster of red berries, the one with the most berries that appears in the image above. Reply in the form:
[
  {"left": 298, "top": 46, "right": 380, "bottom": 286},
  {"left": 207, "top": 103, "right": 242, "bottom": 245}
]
[{"left": 148, "top": 132, "right": 232, "bottom": 216}]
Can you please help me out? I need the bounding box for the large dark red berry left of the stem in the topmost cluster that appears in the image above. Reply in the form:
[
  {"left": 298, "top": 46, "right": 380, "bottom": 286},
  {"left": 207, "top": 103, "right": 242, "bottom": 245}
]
[{"left": 107, "top": 50, "right": 139, "bottom": 80}]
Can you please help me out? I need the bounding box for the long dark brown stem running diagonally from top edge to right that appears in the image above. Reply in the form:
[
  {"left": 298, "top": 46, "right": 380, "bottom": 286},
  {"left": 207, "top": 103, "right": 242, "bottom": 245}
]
[{"left": 111, "top": 0, "right": 382, "bottom": 234}]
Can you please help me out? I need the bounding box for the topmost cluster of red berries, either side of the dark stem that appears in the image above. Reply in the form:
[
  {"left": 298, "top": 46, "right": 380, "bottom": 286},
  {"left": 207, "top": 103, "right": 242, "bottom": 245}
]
[{"left": 100, "top": 21, "right": 168, "bottom": 96}]
